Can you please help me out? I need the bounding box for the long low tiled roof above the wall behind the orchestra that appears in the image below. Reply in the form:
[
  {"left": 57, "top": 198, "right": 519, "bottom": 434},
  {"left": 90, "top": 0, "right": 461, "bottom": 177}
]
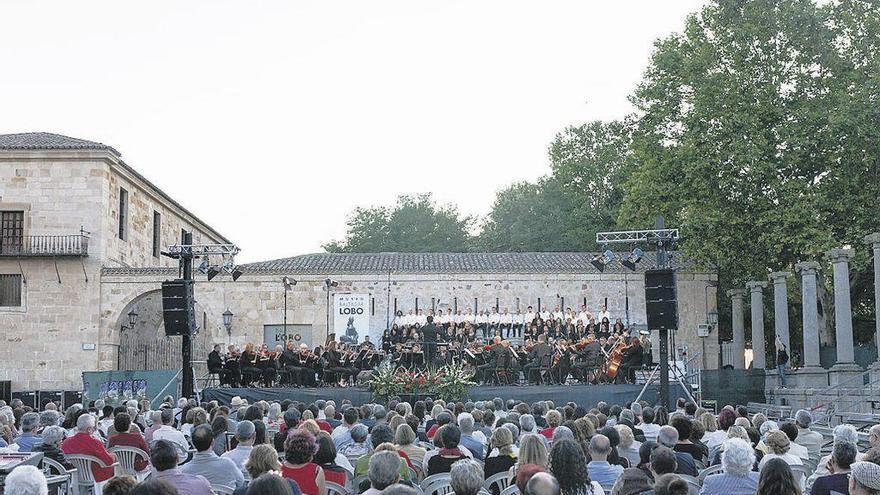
[{"left": 242, "top": 252, "right": 692, "bottom": 274}]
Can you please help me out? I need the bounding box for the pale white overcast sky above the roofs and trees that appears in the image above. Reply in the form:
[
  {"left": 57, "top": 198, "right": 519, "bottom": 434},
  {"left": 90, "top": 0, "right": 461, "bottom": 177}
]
[{"left": 0, "top": 0, "right": 703, "bottom": 262}]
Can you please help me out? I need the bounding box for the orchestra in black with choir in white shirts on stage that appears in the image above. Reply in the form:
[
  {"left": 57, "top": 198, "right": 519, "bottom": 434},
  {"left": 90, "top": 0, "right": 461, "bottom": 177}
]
[{"left": 208, "top": 306, "right": 650, "bottom": 387}]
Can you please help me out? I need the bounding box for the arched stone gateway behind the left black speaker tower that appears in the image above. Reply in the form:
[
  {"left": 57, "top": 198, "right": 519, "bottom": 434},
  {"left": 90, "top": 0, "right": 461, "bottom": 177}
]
[{"left": 116, "top": 289, "right": 210, "bottom": 376}]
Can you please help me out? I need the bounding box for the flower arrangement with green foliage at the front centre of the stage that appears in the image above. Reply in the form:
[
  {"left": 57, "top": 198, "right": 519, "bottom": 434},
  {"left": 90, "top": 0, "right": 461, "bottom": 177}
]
[{"left": 366, "top": 363, "right": 476, "bottom": 401}]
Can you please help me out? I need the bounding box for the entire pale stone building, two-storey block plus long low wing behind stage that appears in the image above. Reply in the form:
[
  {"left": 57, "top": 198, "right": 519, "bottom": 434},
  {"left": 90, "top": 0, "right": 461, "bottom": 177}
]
[{"left": 0, "top": 134, "right": 720, "bottom": 396}]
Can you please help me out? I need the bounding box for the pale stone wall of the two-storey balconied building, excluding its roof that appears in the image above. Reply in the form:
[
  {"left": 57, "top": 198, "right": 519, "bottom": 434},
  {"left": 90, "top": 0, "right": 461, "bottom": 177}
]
[{"left": 0, "top": 151, "right": 230, "bottom": 390}]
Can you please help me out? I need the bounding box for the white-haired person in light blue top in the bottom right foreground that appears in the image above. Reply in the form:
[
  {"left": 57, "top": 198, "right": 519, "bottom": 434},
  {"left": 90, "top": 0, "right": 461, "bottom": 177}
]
[{"left": 700, "top": 440, "right": 758, "bottom": 495}]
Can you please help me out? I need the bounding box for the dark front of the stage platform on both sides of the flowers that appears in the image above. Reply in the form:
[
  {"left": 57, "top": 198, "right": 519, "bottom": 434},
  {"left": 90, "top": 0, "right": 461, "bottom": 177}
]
[{"left": 202, "top": 385, "right": 684, "bottom": 408}]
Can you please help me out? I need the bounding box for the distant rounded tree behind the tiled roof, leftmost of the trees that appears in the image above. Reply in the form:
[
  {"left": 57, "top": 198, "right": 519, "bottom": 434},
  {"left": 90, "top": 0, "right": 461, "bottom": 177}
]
[{"left": 323, "top": 194, "right": 472, "bottom": 253}]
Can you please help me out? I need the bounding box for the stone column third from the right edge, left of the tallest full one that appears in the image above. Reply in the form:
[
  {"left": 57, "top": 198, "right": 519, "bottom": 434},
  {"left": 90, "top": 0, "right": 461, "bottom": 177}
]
[{"left": 789, "top": 261, "right": 828, "bottom": 388}]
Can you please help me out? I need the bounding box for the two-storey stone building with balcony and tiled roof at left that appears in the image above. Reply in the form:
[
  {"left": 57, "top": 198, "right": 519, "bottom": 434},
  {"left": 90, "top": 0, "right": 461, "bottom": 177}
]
[{"left": 0, "top": 133, "right": 229, "bottom": 390}]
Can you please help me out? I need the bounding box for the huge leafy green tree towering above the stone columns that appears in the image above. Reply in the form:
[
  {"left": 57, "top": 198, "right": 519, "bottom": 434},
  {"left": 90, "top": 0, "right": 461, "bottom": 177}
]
[{"left": 619, "top": 0, "right": 880, "bottom": 348}]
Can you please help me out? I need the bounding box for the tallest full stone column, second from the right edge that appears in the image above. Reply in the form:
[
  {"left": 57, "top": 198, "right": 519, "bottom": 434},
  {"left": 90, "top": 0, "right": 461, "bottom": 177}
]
[{"left": 825, "top": 249, "right": 861, "bottom": 386}]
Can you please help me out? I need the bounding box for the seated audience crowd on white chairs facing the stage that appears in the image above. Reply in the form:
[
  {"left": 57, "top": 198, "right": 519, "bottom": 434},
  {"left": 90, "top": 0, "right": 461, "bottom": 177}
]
[{"left": 0, "top": 397, "right": 880, "bottom": 495}]
